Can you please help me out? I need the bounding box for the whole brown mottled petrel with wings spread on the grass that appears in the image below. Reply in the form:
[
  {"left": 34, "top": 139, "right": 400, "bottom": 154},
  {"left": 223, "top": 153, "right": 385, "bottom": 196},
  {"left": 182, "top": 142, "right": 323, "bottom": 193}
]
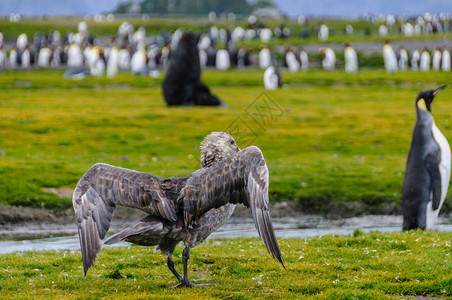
[{"left": 72, "top": 132, "right": 284, "bottom": 286}]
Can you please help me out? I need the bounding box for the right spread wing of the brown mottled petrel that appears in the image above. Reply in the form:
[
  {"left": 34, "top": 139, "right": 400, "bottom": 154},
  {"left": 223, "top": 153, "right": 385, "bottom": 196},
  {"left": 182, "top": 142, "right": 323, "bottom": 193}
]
[{"left": 181, "top": 146, "right": 284, "bottom": 266}]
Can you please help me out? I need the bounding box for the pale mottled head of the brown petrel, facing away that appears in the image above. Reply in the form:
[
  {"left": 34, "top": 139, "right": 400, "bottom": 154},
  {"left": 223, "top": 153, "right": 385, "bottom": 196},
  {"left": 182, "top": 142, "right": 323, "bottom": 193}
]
[{"left": 200, "top": 132, "right": 240, "bottom": 168}]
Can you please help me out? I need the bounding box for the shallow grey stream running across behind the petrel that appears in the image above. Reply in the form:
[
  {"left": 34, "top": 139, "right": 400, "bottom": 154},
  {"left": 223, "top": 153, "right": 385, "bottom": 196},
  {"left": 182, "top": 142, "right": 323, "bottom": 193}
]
[{"left": 0, "top": 208, "right": 452, "bottom": 254}]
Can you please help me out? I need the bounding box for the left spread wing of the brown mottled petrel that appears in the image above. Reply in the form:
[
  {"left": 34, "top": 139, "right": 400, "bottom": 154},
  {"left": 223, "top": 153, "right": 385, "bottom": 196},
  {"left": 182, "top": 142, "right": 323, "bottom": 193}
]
[{"left": 72, "top": 164, "right": 186, "bottom": 275}]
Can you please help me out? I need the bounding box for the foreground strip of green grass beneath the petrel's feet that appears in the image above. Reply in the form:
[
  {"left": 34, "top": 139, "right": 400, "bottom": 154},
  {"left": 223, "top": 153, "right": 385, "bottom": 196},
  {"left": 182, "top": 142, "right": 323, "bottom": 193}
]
[{"left": 0, "top": 230, "right": 452, "bottom": 299}]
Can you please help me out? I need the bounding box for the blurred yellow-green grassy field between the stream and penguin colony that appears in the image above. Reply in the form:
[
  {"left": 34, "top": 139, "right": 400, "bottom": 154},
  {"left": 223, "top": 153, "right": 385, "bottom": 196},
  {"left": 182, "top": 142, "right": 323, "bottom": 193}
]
[{"left": 0, "top": 70, "right": 452, "bottom": 215}]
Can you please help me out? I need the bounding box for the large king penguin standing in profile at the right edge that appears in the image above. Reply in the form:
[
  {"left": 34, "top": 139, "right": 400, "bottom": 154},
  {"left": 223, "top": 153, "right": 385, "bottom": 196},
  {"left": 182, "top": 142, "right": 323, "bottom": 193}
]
[{"left": 402, "top": 85, "right": 451, "bottom": 230}]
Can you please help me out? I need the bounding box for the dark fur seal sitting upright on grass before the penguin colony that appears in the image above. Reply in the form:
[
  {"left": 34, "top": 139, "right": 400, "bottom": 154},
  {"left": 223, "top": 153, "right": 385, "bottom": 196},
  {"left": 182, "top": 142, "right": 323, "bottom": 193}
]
[{"left": 162, "top": 32, "right": 223, "bottom": 106}]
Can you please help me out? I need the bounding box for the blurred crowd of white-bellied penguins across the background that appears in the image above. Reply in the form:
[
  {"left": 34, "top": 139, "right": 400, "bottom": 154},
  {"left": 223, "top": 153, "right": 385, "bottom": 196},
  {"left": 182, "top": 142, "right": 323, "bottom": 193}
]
[{"left": 0, "top": 13, "right": 452, "bottom": 77}]
